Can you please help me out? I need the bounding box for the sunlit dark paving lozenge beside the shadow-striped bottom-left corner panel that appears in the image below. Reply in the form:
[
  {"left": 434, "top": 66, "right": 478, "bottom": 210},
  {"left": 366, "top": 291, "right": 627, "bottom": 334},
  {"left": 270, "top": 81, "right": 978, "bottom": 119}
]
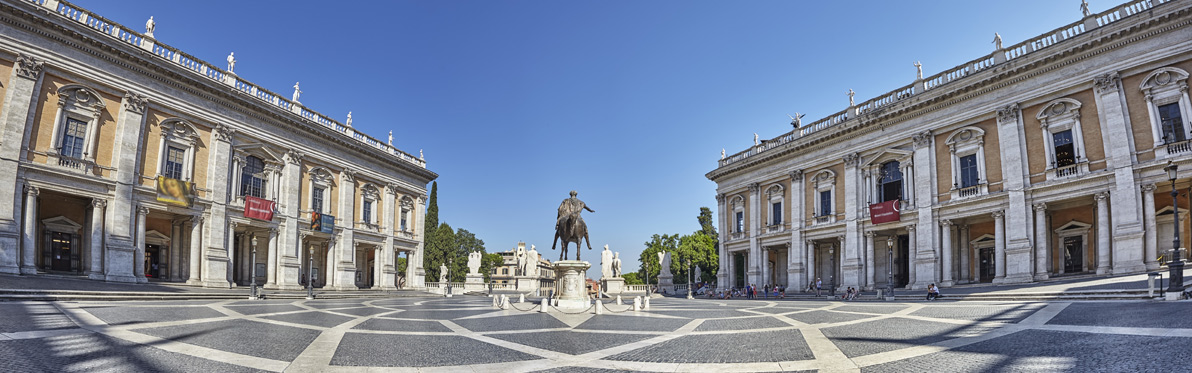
[{"left": 134, "top": 319, "right": 319, "bottom": 361}]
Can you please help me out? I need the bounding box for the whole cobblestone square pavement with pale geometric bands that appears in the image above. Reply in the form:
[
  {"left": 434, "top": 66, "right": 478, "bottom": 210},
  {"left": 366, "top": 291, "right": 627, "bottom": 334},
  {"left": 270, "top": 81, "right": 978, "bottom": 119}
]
[{"left": 0, "top": 297, "right": 1192, "bottom": 372}]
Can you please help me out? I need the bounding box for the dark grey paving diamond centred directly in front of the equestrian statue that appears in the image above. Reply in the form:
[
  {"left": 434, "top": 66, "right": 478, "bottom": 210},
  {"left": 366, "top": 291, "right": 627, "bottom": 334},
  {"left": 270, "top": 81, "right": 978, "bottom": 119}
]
[{"left": 489, "top": 331, "right": 656, "bottom": 355}]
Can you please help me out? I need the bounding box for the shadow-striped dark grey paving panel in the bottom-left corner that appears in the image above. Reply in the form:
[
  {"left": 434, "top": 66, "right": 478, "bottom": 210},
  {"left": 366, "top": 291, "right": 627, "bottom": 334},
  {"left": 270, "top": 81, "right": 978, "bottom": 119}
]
[{"left": 0, "top": 334, "right": 263, "bottom": 372}]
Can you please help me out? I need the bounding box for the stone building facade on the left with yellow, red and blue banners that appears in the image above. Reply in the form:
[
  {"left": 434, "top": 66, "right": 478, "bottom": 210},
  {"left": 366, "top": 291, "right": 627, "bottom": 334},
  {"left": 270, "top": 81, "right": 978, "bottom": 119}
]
[{"left": 0, "top": 0, "right": 437, "bottom": 290}]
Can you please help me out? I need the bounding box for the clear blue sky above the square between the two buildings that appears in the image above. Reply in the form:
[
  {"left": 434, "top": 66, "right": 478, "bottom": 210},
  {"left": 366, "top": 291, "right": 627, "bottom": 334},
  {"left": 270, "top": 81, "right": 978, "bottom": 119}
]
[{"left": 75, "top": 0, "right": 1091, "bottom": 276}]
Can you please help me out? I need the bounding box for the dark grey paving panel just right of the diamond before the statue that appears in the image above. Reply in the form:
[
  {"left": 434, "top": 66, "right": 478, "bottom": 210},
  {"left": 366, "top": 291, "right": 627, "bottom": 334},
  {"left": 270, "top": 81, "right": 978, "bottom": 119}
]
[{"left": 608, "top": 330, "right": 815, "bottom": 363}]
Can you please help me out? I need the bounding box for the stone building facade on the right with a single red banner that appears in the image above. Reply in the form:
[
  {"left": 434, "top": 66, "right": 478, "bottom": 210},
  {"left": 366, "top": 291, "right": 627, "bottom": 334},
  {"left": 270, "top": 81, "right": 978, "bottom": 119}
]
[{"left": 707, "top": 0, "right": 1192, "bottom": 288}]
